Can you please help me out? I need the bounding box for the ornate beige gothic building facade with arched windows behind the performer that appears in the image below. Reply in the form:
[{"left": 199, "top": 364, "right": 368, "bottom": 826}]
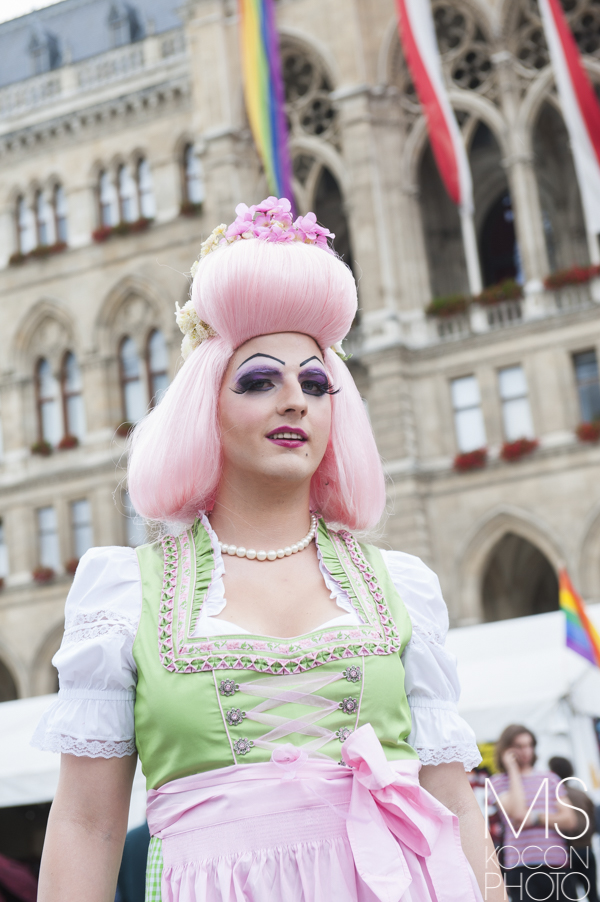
[{"left": 0, "top": 0, "right": 600, "bottom": 700}]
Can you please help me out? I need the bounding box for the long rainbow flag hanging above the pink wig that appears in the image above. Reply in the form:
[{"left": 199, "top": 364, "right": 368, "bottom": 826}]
[{"left": 239, "top": 0, "right": 293, "bottom": 206}]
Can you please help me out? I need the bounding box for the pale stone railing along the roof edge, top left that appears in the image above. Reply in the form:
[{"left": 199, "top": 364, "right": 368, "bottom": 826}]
[{"left": 0, "top": 28, "right": 185, "bottom": 120}]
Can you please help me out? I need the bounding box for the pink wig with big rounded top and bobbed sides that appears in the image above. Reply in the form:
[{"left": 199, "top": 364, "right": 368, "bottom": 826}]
[{"left": 128, "top": 239, "right": 385, "bottom": 530}]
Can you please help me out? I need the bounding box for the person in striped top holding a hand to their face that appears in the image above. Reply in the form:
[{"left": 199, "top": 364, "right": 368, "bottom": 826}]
[{"left": 492, "top": 724, "right": 577, "bottom": 902}]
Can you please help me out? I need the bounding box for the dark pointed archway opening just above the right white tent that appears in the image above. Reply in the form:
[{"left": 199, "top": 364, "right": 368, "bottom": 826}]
[{"left": 481, "top": 532, "right": 558, "bottom": 622}]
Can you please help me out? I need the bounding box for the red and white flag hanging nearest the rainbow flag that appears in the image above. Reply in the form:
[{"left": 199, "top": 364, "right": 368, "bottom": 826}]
[{"left": 396, "top": 0, "right": 473, "bottom": 213}]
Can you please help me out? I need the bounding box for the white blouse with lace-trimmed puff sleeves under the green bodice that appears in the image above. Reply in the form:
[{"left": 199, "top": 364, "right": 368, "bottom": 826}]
[{"left": 32, "top": 536, "right": 481, "bottom": 770}]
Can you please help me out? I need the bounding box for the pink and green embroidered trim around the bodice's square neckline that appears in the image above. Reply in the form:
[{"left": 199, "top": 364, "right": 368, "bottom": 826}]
[{"left": 158, "top": 521, "right": 401, "bottom": 674}]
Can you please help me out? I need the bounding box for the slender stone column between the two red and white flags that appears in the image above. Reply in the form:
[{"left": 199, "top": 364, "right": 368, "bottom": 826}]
[{"left": 492, "top": 50, "right": 549, "bottom": 282}]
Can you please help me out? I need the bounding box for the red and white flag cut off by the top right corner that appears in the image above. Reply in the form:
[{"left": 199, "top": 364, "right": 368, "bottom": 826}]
[{"left": 539, "top": 0, "right": 600, "bottom": 240}]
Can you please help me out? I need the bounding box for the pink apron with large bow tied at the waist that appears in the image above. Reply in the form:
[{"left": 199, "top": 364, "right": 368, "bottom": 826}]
[{"left": 148, "top": 724, "right": 482, "bottom": 902}]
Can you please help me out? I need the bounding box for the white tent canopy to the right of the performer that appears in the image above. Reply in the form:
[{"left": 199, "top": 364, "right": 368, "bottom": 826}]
[{"left": 447, "top": 605, "right": 600, "bottom": 790}]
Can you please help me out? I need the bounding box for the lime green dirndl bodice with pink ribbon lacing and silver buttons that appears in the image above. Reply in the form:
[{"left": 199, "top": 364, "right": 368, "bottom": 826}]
[{"left": 133, "top": 520, "right": 417, "bottom": 902}]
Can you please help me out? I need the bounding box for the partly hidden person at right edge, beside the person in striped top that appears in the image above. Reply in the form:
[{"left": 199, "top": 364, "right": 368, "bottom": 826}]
[{"left": 548, "top": 755, "right": 599, "bottom": 902}]
